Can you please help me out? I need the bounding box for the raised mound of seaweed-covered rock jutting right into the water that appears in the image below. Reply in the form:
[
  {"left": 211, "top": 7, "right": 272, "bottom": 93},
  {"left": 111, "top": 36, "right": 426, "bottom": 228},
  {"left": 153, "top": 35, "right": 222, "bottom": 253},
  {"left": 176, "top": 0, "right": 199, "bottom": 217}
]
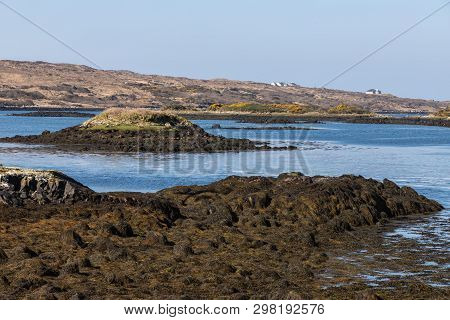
[{"left": 159, "top": 173, "right": 442, "bottom": 233}]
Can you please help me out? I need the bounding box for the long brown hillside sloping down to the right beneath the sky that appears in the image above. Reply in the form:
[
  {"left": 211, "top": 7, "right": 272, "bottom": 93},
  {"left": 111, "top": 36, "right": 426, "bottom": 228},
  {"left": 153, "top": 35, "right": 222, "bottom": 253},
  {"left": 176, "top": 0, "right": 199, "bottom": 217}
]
[{"left": 0, "top": 60, "right": 449, "bottom": 112}]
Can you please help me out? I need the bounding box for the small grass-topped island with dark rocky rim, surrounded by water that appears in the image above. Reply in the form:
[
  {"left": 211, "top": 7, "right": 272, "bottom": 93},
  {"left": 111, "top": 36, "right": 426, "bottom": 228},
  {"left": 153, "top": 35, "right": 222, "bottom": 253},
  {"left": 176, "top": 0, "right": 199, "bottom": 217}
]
[{"left": 0, "top": 108, "right": 271, "bottom": 153}]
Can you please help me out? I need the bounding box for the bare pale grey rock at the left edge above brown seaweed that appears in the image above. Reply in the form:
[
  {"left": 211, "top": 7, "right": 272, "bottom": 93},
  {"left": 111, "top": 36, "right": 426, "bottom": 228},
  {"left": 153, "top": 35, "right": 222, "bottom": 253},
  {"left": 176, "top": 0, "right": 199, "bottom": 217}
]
[{"left": 0, "top": 167, "right": 93, "bottom": 206}]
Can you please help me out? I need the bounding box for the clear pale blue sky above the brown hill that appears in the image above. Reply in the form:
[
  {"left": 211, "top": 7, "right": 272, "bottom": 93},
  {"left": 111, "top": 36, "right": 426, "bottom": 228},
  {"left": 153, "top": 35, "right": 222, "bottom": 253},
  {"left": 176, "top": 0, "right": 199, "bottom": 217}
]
[{"left": 0, "top": 0, "right": 450, "bottom": 100}]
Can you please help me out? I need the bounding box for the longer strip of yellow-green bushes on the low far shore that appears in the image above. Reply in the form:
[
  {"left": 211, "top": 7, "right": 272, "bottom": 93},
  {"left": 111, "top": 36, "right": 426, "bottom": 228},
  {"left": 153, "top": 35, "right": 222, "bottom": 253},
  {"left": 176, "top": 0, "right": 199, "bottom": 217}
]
[{"left": 208, "top": 102, "right": 313, "bottom": 113}]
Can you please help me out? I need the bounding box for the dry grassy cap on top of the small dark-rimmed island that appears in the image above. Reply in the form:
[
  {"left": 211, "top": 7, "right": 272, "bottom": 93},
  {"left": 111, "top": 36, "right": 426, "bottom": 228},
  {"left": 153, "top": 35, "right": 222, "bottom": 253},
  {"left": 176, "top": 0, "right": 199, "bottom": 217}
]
[{"left": 81, "top": 108, "right": 193, "bottom": 131}]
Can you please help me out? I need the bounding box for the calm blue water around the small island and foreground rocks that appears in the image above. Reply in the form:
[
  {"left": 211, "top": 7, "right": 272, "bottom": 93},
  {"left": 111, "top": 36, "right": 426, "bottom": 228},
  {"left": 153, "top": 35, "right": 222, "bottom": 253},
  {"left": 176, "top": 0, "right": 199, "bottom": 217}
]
[{"left": 0, "top": 111, "right": 450, "bottom": 285}]
